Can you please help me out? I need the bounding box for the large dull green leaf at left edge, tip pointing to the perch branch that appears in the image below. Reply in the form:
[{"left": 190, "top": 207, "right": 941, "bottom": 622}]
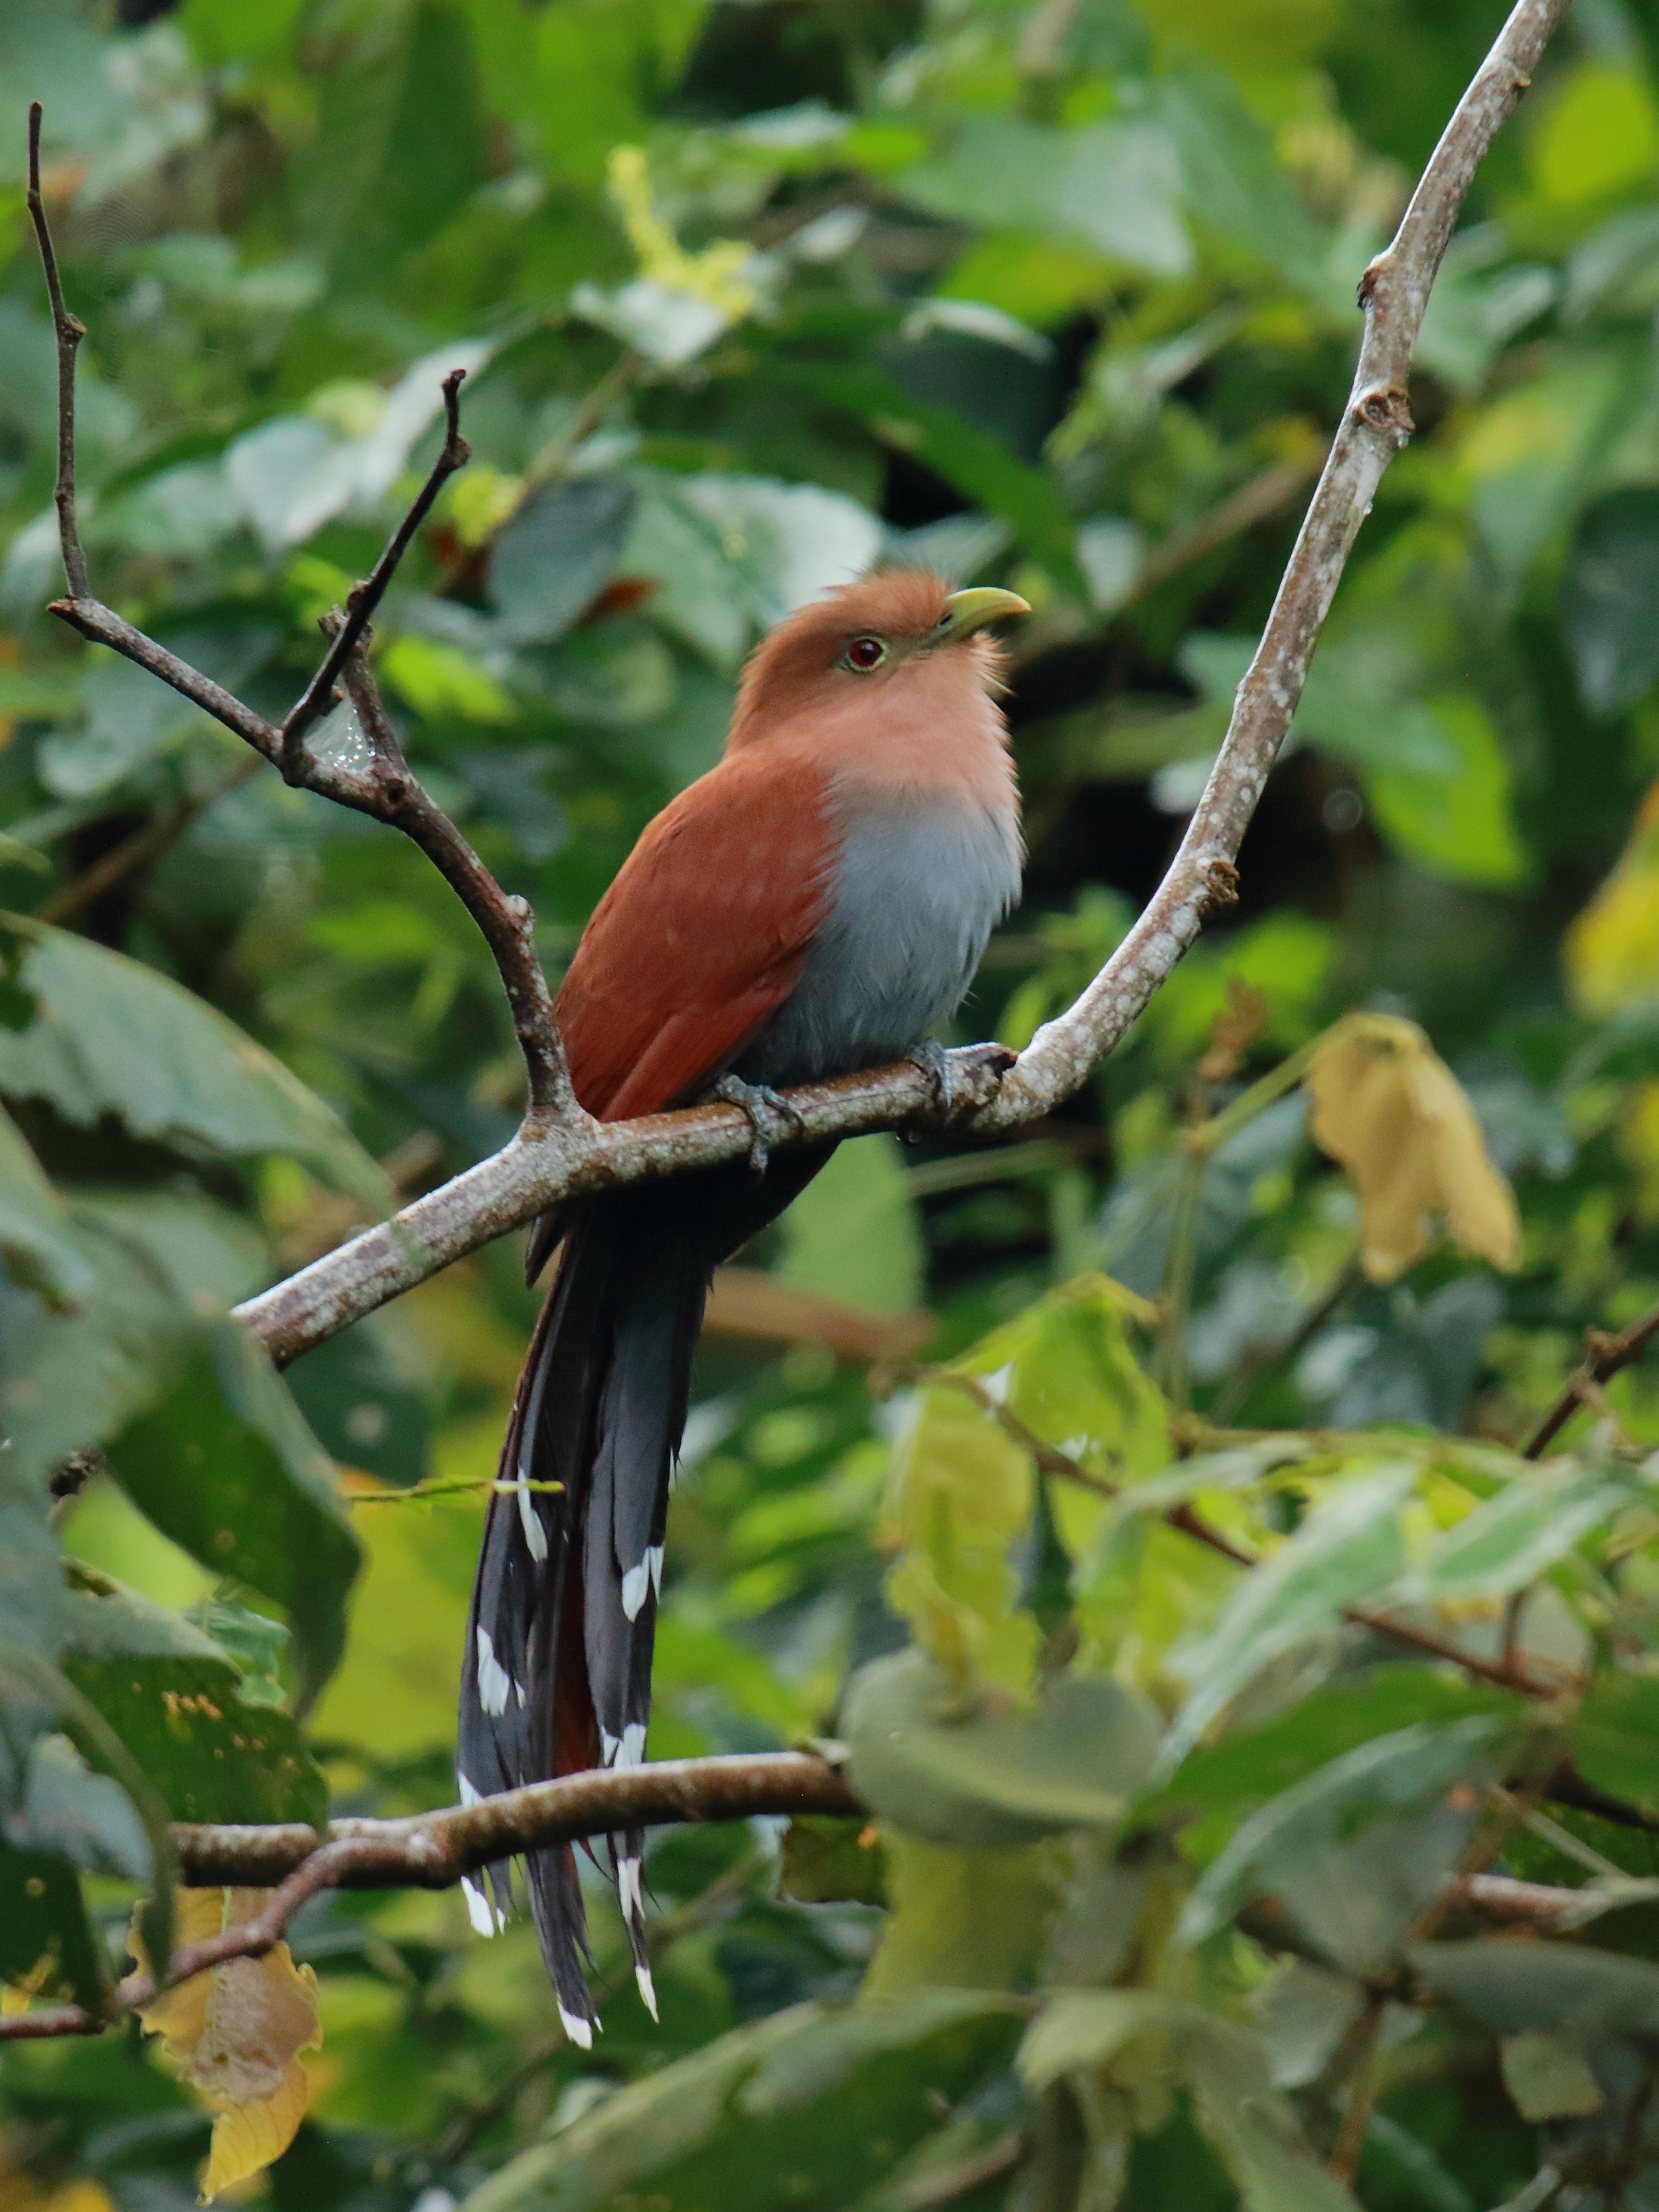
[{"left": 0, "top": 916, "right": 390, "bottom": 1205}]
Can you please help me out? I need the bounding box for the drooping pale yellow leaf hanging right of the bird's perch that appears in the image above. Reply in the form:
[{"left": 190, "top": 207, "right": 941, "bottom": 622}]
[{"left": 1305, "top": 1013, "right": 1520, "bottom": 1283}]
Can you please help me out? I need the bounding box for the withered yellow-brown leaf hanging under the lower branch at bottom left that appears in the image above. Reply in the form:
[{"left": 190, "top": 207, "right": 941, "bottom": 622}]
[{"left": 131, "top": 1889, "right": 323, "bottom": 2203}]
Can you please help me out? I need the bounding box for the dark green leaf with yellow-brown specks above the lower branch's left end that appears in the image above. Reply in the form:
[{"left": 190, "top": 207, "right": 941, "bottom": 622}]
[{"left": 62, "top": 1568, "right": 327, "bottom": 1827}]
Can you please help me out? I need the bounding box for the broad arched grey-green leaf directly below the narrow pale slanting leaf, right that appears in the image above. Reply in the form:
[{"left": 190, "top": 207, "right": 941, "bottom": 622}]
[{"left": 1179, "top": 1714, "right": 1506, "bottom": 1971}]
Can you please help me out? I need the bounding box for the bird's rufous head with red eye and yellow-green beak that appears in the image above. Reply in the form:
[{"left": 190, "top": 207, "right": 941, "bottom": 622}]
[{"left": 730, "top": 569, "right": 1031, "bottom": 745}]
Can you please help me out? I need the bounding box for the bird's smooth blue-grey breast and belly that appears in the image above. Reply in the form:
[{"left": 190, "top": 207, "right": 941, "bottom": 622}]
[{"left": 737, "top": 808, "right": 1020, "bottom": 1084}]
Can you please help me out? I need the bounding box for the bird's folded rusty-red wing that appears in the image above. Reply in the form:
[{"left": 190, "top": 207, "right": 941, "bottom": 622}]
[{"left": 557, "top": 750, "right": 841, "bottom": 1122}]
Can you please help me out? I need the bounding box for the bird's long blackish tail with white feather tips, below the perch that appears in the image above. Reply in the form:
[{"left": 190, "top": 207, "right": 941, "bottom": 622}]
[{"left": 456, "top": 1150, "right": 830, "bottom": 2046}]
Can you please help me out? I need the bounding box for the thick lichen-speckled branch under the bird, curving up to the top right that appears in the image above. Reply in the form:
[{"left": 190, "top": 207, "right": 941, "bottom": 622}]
[{"left": 228, "top": 0, "right": 1566, "bottom": 1361}]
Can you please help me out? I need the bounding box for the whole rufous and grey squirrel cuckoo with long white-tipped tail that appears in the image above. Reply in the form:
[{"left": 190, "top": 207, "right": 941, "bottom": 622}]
[{"left": 458, "top": 569, "right": 1029, "bottom": 2046}]
